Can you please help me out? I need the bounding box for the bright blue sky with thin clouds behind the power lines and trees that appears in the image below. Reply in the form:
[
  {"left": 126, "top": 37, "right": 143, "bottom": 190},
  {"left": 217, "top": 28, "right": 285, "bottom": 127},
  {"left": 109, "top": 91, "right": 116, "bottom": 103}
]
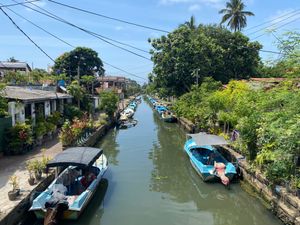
[{"left": 0, "top": 0, "right": 300, "bottom": 83}]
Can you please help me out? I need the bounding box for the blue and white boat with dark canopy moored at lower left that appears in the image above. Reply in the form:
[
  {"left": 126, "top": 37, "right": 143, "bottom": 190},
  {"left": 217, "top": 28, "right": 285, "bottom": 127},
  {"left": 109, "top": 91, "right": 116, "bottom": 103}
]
[{"left": 29, "top": 147, "right": 108, "bottom": 220}]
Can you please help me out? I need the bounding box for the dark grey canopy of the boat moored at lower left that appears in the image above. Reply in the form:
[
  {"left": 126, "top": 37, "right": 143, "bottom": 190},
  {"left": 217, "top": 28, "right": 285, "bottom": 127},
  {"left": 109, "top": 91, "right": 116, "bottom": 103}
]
[{"left": 47, "top": 147, "right": 103, "bottom": 168}]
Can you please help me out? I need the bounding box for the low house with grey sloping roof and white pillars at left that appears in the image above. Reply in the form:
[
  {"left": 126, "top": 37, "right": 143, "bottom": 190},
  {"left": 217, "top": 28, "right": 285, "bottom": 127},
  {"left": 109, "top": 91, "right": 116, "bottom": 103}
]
[{"left": 3, "top": 86, "right": 73, "bottom": 126}]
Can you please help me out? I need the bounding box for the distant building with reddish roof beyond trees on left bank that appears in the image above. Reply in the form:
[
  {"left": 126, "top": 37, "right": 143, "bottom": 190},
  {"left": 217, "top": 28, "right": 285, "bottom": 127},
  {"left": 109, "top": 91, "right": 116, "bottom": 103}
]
[{"left": 96, "top": 76, "right": 128, "bottom": 99}]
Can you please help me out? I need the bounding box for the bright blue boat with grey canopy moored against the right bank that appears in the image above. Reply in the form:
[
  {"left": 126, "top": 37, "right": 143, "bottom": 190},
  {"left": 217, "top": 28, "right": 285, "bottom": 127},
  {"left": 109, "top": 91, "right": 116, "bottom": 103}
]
[{"left": 184, "top": 132, "right": 236, "bottom": 186}]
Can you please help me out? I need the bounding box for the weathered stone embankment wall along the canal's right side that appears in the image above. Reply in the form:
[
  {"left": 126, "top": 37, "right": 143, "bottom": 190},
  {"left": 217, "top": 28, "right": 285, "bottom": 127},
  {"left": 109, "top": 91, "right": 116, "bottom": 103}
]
[{"left": 148, "top": 96, "right": 300, "bottom": 225}]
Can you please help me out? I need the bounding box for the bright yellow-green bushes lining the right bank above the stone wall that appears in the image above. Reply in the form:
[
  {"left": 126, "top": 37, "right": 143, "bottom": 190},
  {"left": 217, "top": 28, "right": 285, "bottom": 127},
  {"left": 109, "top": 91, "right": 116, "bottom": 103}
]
[{"left": 173, "top": 80, "right": 300, "bottom": 183}]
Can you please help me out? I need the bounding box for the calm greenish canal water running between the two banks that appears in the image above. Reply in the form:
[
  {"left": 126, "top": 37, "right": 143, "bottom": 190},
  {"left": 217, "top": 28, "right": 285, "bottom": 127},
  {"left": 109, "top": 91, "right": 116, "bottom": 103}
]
[{"left": 64, "top": 99, "right": 282, "bottom": 225}]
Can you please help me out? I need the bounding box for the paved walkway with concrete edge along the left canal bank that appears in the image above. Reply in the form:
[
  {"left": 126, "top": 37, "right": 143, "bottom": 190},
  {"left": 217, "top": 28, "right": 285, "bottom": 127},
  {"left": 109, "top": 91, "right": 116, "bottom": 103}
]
[{"left": 0, "top": 97, "right": 134, "bottom": 225}]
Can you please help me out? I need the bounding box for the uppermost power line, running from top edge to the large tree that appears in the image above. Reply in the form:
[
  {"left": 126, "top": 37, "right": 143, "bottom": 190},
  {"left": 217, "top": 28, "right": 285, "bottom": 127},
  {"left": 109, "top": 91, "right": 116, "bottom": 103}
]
[{"left": 48, "top": 0, "right": 170, "bottom": 33}]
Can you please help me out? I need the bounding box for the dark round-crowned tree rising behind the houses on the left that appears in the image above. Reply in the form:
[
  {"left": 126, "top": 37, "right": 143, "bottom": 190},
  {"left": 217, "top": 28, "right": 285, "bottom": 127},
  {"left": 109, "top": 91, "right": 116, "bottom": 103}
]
[{"left": 53, "top": 47, "right": 104, "bottom": 78}]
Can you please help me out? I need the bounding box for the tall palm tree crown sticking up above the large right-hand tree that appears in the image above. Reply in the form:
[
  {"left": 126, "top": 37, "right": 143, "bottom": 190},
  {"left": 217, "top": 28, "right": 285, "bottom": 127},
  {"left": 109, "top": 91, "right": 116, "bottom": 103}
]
[{"left": 219, "top": 0, "right": 254, "bottom": 32}]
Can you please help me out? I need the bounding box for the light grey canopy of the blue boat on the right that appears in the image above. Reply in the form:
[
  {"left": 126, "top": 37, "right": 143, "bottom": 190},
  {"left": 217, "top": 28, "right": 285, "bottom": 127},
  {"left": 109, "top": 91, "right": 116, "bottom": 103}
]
[{"left": 187, "top": 132, "right": 228, "bottom": 146}]
